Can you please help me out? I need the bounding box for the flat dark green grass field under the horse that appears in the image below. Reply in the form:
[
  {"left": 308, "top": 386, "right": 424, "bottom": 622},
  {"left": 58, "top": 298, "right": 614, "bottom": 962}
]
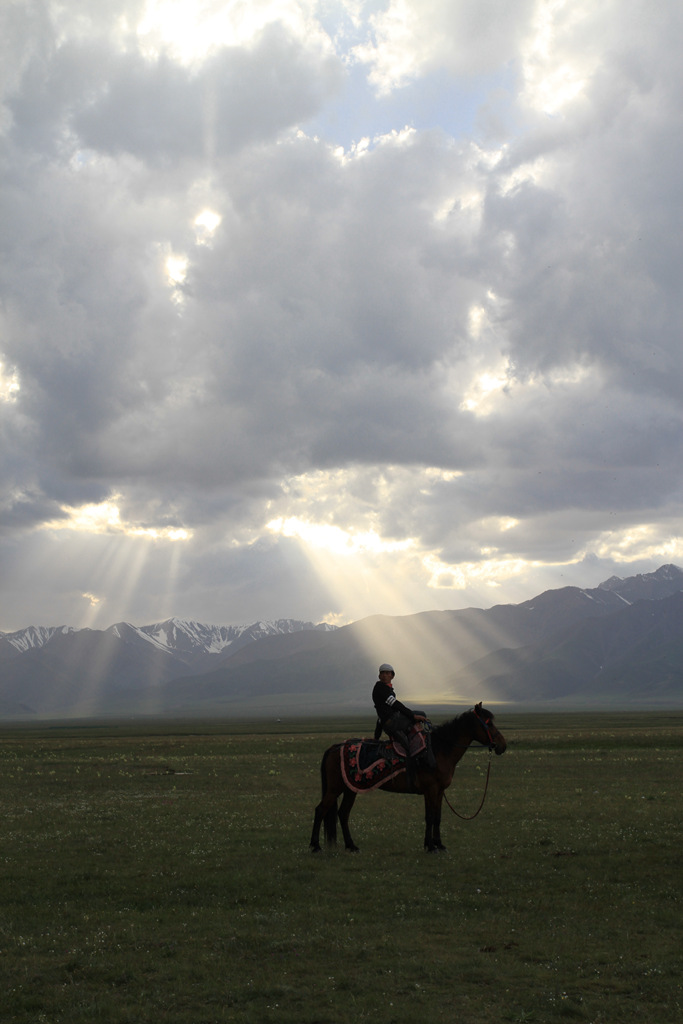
[{"left": 0, "top": 712, "right": 683, "bottom": 1024}]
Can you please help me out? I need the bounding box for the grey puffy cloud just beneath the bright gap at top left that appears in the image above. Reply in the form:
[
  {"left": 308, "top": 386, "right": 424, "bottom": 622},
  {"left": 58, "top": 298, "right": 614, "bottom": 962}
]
[{"left": 71, "top": 25, "right": 341, "bottom": 165}]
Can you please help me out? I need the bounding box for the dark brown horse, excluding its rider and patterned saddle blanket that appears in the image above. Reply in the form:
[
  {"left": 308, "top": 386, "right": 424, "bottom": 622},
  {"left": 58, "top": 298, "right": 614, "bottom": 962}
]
[{"left": 310, "top": 702, "right": 507, "bottom": 853}]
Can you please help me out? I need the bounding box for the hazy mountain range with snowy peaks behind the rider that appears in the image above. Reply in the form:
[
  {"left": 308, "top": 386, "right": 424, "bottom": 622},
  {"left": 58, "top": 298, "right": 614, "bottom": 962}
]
[{"left": 0, "top": 565, "right": 683, "bottom": 719}]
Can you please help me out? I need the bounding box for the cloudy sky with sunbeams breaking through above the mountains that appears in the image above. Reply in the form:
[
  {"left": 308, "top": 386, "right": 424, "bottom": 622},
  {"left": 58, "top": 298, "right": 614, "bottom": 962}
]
[{"left": 0, "top": 0, "right": 683, "bottom": 632}]
